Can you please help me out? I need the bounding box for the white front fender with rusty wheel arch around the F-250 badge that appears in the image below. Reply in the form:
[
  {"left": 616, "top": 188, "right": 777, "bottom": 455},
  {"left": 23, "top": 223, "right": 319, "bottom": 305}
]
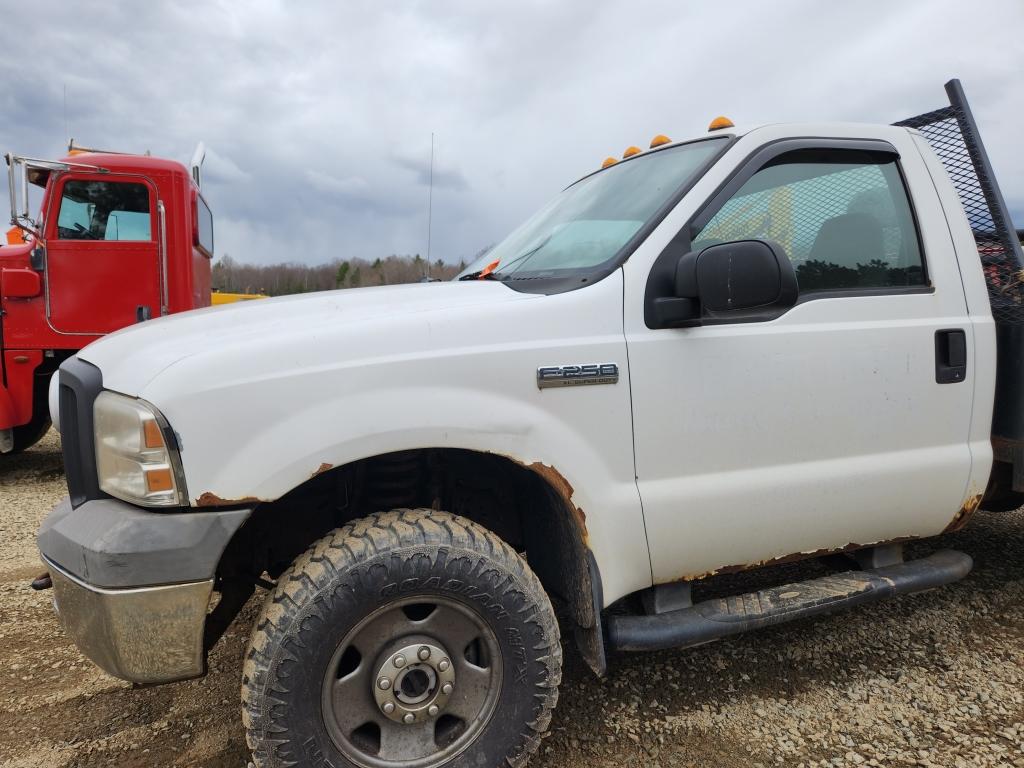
[{"left": 141, "top": 272, "right": 651, "bottom": 603}]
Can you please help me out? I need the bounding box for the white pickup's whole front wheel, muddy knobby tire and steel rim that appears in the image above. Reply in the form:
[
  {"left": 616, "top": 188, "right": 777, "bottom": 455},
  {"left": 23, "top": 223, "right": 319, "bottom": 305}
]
[{"left": 242, "top": 510, "right": 561, "bottom": 768}]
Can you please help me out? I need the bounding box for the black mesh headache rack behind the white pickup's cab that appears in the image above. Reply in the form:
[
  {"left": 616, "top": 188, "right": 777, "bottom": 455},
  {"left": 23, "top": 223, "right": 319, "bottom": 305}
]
[{"left": 896, "top": 80, "right": 1024, "bottom": 492}]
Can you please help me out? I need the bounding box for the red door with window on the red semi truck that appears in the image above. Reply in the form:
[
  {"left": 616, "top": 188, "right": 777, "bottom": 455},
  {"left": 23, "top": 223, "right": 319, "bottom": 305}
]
[{"left": 46, "top": 174, "right": 161, "bottom": 336}]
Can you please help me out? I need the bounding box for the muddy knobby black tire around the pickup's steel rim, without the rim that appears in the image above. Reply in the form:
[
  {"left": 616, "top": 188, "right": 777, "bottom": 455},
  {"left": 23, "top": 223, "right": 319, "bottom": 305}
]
[{"left": 242, "top": 509, "right": 562, "bottom": 768}]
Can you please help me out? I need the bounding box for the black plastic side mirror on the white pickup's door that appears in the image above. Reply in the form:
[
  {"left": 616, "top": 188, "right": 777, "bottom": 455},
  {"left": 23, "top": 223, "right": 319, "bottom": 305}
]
[{"left": 655, "top": 240, "right": 799, "bottom": 328}]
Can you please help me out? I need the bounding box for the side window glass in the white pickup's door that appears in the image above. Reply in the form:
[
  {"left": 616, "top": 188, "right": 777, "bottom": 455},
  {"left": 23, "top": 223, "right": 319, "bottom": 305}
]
[{"left": 693, "top": 150, "right": 926, "bottom": 293}]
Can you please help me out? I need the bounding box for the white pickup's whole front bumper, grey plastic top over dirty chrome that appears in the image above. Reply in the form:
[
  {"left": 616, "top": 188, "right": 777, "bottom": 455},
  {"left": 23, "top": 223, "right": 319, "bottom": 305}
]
[{"left": 38, "top": 499, "right": 252, "bottom": 683}]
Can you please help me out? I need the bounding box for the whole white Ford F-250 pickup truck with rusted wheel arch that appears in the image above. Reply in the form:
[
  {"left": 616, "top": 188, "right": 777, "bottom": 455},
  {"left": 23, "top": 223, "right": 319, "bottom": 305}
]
[{"left": 39, "top": 81, "right": 1024, "bottom": 768}]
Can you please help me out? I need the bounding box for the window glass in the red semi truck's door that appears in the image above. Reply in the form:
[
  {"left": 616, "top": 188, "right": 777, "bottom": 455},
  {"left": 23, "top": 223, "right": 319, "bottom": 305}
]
[{"left": 57, "top": 179, "right": 153, "bottom": 241}]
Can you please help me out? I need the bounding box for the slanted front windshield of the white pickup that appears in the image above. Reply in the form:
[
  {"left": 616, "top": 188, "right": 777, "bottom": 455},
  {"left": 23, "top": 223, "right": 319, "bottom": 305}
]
[{"left": 457, "top": 136, "right": 728, "bottom": 293}]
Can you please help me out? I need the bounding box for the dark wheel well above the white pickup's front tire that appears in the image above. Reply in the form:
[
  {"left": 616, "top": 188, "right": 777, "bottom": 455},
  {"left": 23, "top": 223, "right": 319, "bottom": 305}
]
[{"left": 218, "top": 449, "right": 603, "bottom": 670}]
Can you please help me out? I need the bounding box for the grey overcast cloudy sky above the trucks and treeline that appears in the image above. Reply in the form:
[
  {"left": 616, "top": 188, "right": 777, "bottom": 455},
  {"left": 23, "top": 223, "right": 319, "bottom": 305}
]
[{"left": 0, "top": 0, "right": 1024, "bottom": 263}]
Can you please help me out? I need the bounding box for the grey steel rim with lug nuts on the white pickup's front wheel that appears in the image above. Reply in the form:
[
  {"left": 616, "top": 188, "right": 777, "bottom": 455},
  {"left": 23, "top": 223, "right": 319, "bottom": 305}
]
[{"left": 322, "top": 595, "right": 502, "bottom": 768}]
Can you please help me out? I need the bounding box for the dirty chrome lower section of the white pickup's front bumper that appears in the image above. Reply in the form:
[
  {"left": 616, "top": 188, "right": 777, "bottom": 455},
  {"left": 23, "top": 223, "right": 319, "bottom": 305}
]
[{"left": 43, "top": 557, "right": 213, "bottom": 683}]
